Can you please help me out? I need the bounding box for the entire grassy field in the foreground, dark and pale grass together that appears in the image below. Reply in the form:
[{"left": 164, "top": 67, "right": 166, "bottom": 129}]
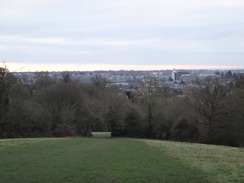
[{"left": 0, "top": 134, "right": 244, "bottom": 183}]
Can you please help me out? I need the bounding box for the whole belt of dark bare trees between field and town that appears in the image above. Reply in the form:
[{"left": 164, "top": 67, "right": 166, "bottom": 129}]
[{"left": 0, "top": 72, "right": 244, "bottom": 146}]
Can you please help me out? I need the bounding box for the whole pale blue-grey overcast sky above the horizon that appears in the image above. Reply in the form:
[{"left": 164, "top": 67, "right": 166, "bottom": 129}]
[{"left": 0, "top": 0, "right": 244, "bottom": 70}]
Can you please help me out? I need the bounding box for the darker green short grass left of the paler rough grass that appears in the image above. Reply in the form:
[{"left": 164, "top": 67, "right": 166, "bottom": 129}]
[{"left": 0, "top": 138, "right": 243, "bottom": 183}]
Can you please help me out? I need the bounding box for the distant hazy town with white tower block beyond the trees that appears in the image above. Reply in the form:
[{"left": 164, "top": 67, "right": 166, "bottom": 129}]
[{"left": 12, "top": 69, "right": 244, "bottom": 90}]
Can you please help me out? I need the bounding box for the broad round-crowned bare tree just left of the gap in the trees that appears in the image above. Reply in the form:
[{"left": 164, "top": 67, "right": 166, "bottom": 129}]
[{"left": 39, "top": 83, "right": 90, "bottom": 136}]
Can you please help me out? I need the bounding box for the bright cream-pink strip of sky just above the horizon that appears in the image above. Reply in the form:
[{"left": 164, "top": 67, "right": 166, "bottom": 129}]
[{"left": 4, "top": 62, "right": 244, "bottom": 72}]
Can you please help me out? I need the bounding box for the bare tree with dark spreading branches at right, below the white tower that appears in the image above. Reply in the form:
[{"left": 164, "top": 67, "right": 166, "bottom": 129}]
[{"left": 192, "top": 79, "right": 231, "bottom": 141}]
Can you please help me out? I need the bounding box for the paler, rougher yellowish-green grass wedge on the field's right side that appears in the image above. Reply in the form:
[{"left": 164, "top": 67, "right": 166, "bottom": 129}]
[{"left": 140, "top": 140, "right": 244, "bottom": 183}]
